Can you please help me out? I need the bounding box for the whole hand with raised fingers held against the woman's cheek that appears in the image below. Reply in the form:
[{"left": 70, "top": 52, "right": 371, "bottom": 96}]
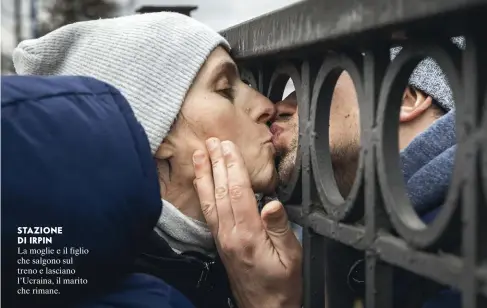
[{"left": 193, "top": 138, "right": 302, "bottom": 308}]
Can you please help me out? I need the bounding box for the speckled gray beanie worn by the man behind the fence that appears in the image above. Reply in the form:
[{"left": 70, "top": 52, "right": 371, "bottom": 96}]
[{"left": 391, "top": 36, "right": 465, "bottom": 111}]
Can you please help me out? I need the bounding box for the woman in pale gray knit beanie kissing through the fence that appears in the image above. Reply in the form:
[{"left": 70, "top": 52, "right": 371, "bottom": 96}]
[{"left": 13, "top": 13, "right": 301, "bottom": 307}]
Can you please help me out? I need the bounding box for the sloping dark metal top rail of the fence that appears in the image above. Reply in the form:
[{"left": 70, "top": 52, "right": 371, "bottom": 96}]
[{"left": 221, "top": 0, "right": 487, "bottom": 59}]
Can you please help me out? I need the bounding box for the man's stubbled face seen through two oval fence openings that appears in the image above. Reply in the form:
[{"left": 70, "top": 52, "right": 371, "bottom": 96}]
[{"left": 271, "top": 72, "right": 360, "bottom": 196}]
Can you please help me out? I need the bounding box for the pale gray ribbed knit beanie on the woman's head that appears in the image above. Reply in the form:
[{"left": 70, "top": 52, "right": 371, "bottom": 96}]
[{"left": 13, "top": 12, "right": 230, "bottom": 154}]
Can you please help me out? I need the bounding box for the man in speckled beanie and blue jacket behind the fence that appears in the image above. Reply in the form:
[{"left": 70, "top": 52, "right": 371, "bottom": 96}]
[{"left": 271, "top": 38, "right": 464, "bottom": 307}]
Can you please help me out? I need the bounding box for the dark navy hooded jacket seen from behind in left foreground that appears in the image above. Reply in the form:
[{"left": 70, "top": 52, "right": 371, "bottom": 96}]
[{"left": 1, "top": 76, "right": 196, "bottom": 308}]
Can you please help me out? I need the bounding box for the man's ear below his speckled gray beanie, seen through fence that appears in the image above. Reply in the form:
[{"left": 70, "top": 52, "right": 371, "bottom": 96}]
[{"left": 399, "top": 87, "right": 433, "bottom": 123}]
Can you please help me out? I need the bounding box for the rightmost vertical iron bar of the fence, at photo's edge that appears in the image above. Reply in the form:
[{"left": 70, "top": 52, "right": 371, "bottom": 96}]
[{"left": 460, "top": 30, "right": 487, "bottom": 308}]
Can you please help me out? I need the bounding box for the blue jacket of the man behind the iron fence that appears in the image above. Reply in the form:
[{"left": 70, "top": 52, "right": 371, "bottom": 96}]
[{"left": 394, "top": 110, "right": 461, "bottom": 308}]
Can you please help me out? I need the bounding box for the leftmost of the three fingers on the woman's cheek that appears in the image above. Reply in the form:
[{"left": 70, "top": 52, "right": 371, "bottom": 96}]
[{"left": 193, "top": 150, "right": 218, "bottom": 235}]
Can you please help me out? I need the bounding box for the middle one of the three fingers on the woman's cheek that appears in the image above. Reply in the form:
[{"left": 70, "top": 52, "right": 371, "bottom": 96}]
[{"left": 206, "top": 138, "right": 235, "bottom": 233}]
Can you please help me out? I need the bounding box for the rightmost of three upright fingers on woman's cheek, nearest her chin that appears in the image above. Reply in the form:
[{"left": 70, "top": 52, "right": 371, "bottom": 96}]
[{"left": 221, "top": 141, "right": 262, "bottom": 228}]
